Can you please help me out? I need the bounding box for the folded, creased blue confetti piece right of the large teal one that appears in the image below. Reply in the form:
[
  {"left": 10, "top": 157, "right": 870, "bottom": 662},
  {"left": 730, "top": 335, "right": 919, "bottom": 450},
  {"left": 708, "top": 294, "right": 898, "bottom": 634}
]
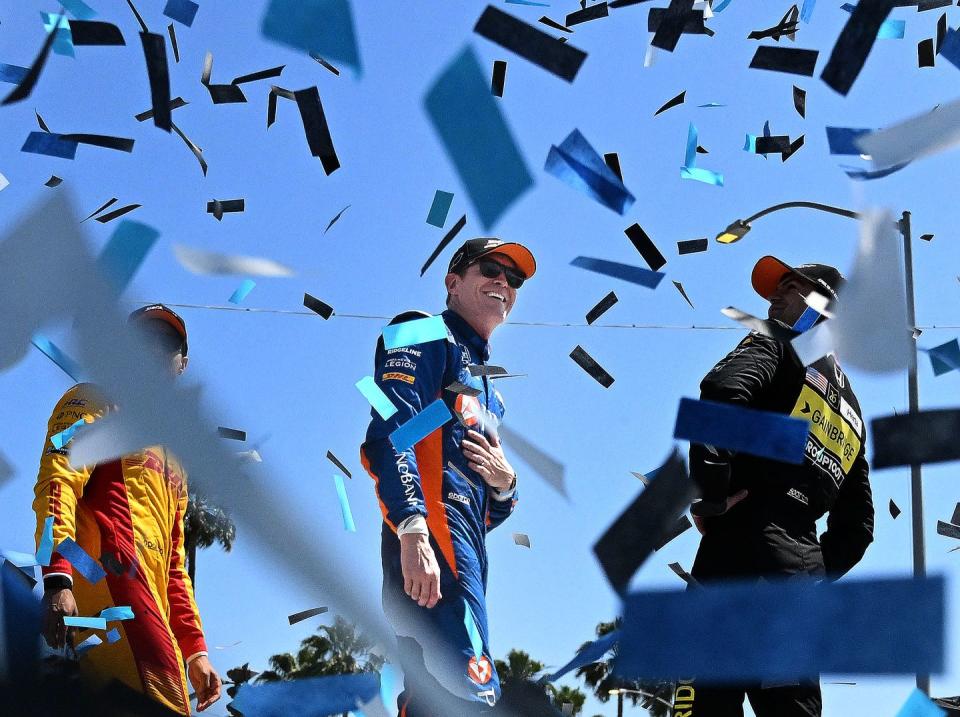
[{"left": 544, "top": 129, "right": 636, "bottom": 216}]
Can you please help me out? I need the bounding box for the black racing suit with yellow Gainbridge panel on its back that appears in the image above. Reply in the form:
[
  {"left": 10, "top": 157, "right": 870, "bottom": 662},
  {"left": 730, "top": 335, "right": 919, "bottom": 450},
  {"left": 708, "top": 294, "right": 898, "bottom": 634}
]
[{"left": 674, "top": 324, "right": 873, "bottom": 717}]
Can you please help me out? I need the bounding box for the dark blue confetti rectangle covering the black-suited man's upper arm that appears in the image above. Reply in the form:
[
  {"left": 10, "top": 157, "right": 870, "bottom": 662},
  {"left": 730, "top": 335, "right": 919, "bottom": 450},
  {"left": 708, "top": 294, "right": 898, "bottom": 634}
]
[{"left": 673, "top": 398, "right": 810, "bottom": 465}]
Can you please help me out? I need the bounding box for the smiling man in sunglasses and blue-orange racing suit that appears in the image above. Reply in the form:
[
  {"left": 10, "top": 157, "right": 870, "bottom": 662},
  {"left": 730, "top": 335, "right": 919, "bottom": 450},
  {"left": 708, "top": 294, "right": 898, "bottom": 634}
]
[{"left": 361, "top": 238, "right": 537, "bottom": 717}]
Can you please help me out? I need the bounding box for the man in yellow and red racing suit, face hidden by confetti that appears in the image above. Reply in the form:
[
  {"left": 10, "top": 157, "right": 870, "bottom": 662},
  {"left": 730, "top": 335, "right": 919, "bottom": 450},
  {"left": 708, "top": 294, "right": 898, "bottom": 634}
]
[{"left": 33, "top": 304, "right": 220, "bottom": 715}]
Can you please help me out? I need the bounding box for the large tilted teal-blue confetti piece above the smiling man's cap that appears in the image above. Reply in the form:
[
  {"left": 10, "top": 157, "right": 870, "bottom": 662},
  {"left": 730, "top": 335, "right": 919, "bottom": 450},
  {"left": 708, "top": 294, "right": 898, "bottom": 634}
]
[{"left": 423, "top": 45, "right": 533, "bottom": 229}]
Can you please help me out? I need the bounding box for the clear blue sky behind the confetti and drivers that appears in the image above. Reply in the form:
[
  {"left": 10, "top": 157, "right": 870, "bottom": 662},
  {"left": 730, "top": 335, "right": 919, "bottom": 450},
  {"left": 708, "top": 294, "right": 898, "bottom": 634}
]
[{"left": 0, "top": 0, "right": 960, "bottom": 715}]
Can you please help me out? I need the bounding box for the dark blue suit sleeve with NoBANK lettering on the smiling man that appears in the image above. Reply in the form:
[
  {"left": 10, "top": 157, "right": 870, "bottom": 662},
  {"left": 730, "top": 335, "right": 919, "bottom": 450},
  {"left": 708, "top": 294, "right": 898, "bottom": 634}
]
[{"left": 361, "top": 315, "right": 447, "bottom": 529}]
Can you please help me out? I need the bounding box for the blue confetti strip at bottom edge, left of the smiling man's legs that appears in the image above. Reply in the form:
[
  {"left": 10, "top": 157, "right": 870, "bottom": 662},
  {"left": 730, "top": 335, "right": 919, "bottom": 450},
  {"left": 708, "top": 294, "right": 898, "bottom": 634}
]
[{"left": 231, "top": 672, "right": 380, "bottom": 715}]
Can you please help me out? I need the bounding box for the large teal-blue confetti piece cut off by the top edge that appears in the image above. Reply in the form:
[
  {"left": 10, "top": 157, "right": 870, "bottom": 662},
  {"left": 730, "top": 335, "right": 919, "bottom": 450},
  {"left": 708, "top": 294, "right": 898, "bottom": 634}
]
[{"left": 260, "top": 0, "right": 361, "bottom": 72}]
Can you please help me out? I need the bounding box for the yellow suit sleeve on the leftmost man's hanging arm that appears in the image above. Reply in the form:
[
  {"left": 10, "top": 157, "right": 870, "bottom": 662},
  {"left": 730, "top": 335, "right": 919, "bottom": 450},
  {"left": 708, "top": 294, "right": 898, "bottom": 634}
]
[{"left": 33, "top": 384, "right": 104, "bottom": 576}]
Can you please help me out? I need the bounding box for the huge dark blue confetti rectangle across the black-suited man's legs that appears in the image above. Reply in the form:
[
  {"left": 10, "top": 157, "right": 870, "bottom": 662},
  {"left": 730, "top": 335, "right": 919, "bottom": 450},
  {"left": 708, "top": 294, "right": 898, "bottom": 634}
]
[{"left": 614, "top": 576, "right": 946, "bottom": 684}]
